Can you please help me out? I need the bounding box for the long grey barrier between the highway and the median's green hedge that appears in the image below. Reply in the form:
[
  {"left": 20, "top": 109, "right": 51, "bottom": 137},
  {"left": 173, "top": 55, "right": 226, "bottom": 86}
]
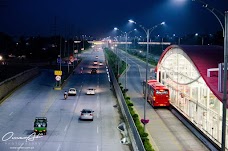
[{"left": 108, "top": 68, "right": 145, "bottom": 151}]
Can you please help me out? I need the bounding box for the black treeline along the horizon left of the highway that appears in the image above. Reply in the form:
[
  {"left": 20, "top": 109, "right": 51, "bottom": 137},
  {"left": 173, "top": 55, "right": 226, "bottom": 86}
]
[{"left": 0, "top": 33, "right": 90, "bottom": 61}]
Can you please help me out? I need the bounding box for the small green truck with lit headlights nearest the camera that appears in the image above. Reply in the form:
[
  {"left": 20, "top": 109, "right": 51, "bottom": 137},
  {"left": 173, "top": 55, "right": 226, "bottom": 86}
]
[{"left": 34, "top": 117, "right": 47, "bottom": 135}]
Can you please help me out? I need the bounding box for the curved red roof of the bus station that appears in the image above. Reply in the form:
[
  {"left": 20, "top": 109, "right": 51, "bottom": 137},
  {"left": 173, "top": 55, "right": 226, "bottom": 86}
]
[{"left": 155, "top": 45, "right": 227, "bottom": 106}]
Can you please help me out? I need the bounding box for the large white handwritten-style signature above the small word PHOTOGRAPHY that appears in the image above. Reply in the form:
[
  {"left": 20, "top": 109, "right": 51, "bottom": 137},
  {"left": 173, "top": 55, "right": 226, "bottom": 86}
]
[{"left": 2, "top": 132, "right": 43, "bottom": 142}]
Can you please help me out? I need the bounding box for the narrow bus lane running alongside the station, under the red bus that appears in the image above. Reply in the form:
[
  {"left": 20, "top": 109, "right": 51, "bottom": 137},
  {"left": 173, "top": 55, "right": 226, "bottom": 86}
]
[{"left": 118, "top": 49, "right": 209, "bottom": 151}]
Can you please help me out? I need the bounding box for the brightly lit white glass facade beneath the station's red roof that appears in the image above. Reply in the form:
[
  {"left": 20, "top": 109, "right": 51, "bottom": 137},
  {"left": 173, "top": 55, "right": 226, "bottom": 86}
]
[{"left": 156, "top": 47, "right": 228, "bottom": 148}]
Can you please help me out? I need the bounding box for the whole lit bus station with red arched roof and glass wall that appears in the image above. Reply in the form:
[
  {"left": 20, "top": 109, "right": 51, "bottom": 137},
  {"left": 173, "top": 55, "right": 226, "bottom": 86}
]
[{"left": 155, "top": 45, "right": 228, "bottom": 149}]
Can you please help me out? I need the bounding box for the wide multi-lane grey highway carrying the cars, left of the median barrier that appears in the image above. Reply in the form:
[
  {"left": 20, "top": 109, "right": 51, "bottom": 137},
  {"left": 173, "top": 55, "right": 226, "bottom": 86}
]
[{"left": 0, "top": 50, "right": 132, "bottom": 151}]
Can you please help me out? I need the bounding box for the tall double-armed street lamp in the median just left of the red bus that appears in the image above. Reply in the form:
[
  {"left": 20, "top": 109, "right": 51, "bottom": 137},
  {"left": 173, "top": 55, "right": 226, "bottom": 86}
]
[{"left": 128, "top": 19, "right": 165, "bottom": 132}]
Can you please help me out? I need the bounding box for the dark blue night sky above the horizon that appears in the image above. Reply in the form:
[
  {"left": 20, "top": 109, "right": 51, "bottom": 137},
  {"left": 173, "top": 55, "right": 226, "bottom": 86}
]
[{"left": 0, "top": 0, "right": 228, "bottom": 38}]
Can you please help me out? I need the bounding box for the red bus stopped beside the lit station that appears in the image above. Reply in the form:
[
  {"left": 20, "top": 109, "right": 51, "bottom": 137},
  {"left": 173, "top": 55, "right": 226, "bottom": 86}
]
[{"left": 143, "top": 80, "right": 170, "bottom": 107}]
